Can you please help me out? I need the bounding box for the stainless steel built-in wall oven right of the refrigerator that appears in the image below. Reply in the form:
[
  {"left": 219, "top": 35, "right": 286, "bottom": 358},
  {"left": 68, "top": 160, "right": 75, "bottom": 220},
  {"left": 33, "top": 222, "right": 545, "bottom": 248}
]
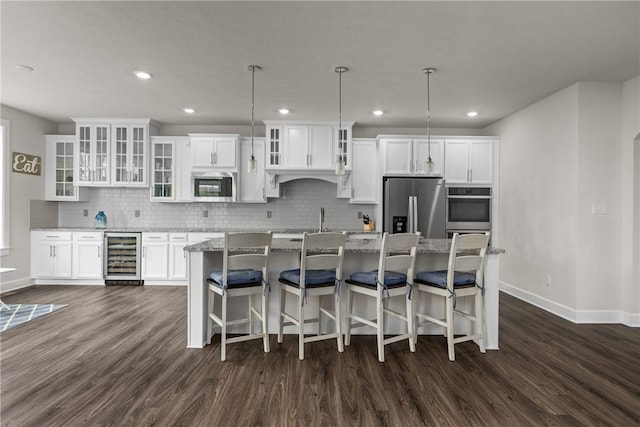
[{"left": 447, "top": 187, "right": 491, "bottom": 233}]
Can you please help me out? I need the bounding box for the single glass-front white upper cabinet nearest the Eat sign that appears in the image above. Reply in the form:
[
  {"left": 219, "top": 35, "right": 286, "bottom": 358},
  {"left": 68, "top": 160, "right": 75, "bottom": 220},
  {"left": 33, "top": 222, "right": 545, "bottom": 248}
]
[{"left": 44, "top": 135, "right": 88, "bottom": 202}]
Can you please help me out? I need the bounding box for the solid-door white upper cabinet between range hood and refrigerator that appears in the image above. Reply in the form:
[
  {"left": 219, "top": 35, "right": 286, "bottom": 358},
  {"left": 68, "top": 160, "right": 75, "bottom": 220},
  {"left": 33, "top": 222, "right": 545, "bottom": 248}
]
[{"left": 350, "top": 138, "right": 381, "bottom": 204}]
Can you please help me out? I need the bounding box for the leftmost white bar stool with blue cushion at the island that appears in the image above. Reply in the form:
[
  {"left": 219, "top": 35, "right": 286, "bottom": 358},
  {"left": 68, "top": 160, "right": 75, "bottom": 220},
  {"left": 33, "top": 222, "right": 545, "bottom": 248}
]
[{"left": 207, "top": 232, "right": 271, "bottom": 361}]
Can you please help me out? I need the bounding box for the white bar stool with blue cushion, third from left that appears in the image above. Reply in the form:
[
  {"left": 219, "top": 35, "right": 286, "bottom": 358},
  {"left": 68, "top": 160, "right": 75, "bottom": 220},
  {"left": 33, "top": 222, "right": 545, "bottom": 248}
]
[{"left": 345, "top": 233, "right": 420, "bottom": 362}]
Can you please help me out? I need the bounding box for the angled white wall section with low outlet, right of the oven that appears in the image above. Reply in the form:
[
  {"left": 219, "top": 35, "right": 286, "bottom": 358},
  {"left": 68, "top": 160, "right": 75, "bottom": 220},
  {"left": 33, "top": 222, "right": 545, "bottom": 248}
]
[{"left": 485, "top": 85, "right": 578, "bottom": 307}]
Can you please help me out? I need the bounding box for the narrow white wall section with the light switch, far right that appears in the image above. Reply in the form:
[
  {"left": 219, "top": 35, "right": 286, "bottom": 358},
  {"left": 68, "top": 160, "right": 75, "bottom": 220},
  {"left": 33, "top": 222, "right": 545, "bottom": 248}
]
[{"left": 576, "top": 82, "right": 623, "bottom": 314}]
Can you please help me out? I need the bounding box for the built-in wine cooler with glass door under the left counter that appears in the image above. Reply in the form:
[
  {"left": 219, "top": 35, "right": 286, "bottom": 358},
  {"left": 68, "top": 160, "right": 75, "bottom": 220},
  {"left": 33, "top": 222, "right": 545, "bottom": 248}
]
[{"left": 104, "top": 233, "right": 143, "bottom": 285}]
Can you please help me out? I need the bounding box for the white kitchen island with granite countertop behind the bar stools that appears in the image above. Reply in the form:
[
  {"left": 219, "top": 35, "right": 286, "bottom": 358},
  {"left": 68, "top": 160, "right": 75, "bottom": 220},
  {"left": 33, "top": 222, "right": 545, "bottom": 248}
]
[{"left": 185, "top": 237, "right": 504, "bottom": 350}]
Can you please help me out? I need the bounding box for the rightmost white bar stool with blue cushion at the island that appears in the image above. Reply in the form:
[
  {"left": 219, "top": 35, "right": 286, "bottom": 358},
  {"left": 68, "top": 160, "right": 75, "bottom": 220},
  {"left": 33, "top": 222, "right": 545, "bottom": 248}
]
[{"left": 415, "top": 232, "right": 489, "bottom": 362}]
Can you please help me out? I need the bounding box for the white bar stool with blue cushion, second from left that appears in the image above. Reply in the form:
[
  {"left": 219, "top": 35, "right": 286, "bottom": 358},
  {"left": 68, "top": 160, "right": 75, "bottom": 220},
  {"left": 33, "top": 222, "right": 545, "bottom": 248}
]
[{"left": 278, "top": 233, "right": 347, "bottom": 360}]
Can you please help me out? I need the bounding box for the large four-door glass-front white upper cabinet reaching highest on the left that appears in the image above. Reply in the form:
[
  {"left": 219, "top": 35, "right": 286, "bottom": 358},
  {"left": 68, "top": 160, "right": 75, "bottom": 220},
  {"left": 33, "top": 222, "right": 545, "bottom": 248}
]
[{"left": 73, "top": 118, "right": 157, "bottom": 187}]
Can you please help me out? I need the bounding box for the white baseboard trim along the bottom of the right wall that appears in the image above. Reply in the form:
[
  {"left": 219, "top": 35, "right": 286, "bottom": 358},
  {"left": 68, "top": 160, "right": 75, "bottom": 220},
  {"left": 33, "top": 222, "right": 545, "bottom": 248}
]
[{"left": 500, "top": 281, "right": 640, "bottom": 327}]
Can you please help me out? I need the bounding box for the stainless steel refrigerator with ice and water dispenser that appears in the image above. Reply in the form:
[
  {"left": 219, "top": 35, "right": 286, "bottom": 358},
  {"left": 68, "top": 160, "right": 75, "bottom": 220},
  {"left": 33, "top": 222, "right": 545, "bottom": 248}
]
[{"left": 382, "top": 177, "right": 447, "bottom": 239}]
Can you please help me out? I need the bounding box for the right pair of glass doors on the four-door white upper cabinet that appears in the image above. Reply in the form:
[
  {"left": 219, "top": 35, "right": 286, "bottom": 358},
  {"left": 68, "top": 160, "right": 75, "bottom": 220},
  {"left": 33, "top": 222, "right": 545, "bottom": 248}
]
[{"left": 111, "top": 124, "right": 149, "bottom": 187}]
